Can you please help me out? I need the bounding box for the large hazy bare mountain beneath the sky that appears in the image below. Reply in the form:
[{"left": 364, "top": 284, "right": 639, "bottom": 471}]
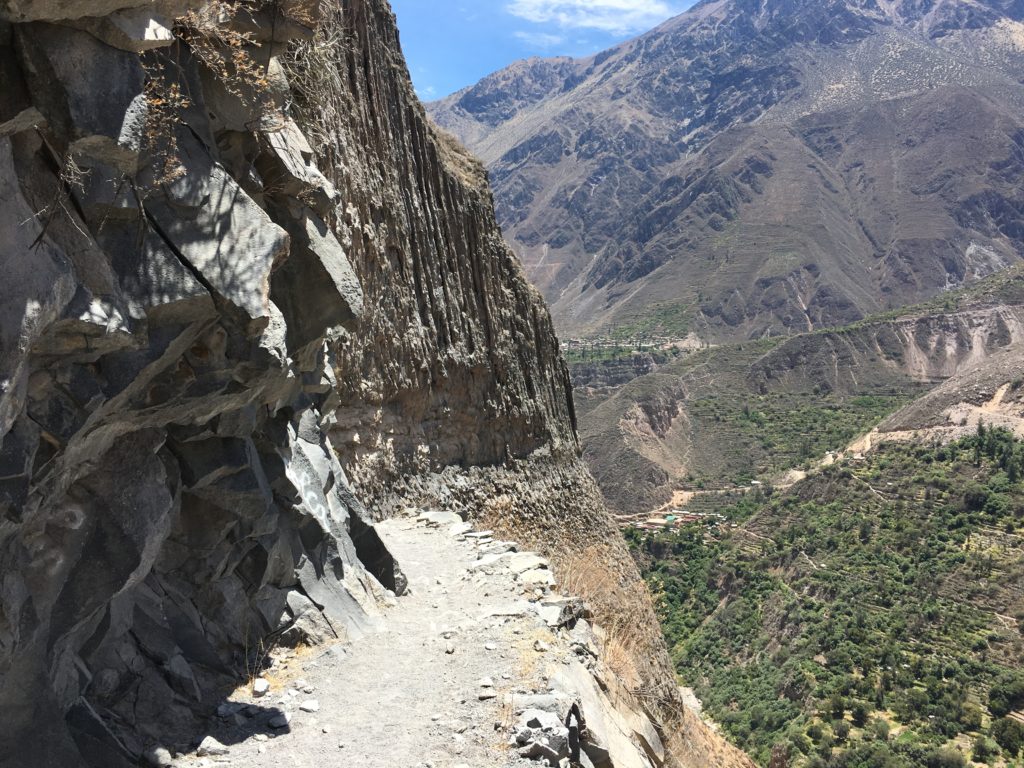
[{"left": 430, "top": 0, "right": 1024, "bottom": 340}]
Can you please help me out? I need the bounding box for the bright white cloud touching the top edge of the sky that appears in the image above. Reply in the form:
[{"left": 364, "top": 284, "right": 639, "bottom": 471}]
[{"left": 505, "top": 0, "right": 678, "bottom": 35}]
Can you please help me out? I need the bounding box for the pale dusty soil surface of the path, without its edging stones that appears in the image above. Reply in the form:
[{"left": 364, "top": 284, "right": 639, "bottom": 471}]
[{"left": 175, "top": 518, "right": 559, "bottom": 768}]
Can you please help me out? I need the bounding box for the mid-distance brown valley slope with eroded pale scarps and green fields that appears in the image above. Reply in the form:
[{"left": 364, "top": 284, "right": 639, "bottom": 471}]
[{"left": 572, "top": 267, "right": 1024, "bottom": 513}]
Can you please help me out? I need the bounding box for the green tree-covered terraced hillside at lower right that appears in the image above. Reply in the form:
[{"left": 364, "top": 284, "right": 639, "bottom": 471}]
[{"left": 629, "top": 428, "right": 1024, "bottom": 768}]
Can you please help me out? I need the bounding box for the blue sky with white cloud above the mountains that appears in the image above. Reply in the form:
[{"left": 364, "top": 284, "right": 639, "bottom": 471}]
[{"left": 391, "top": 0, "right": 693, "bottom": 101}]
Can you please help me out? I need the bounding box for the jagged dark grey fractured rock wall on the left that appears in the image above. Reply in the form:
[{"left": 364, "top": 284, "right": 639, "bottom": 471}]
[{"left": 0, "top": 1, "right": 400, "bottom": 768}]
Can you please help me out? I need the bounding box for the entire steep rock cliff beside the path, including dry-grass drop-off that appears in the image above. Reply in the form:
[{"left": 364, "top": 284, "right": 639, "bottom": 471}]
[{"left": 0, "top": 0, "right": 748, "bottom": 768}]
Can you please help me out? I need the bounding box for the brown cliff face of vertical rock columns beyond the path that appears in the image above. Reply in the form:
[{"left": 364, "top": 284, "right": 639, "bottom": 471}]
[{"left": 276, "top": 3, "right": 579, "bottom": 499}]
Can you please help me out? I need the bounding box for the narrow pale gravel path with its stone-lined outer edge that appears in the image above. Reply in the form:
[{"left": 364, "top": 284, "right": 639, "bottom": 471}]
[{"left": 167, "top": 512, "right": 662, "bottom": 768}]
